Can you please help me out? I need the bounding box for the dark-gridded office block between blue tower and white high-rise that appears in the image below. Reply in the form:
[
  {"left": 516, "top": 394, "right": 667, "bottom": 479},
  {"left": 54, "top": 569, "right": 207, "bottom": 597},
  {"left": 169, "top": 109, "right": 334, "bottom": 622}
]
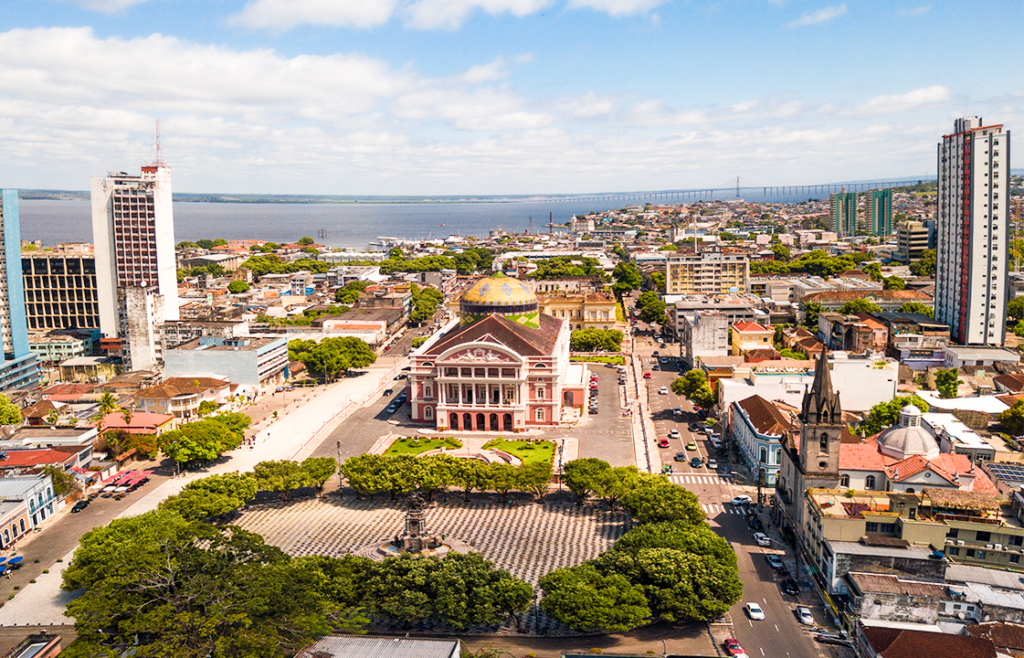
[{"left": 22, "top": 245, "right": 99, "bottom": 332}]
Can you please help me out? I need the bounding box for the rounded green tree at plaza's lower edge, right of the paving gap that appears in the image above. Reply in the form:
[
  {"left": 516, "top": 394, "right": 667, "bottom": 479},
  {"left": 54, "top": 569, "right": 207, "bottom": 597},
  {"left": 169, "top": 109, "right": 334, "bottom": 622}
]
[{"left": 540, "top": 562, "right": 650, "bottom": 631}]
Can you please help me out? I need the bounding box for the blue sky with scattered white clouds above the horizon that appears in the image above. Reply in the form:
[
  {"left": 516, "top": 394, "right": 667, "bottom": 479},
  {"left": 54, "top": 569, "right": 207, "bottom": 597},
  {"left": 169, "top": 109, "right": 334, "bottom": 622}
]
[{"left": 0, "top": 0, "right": 1024, "bottom": 195}]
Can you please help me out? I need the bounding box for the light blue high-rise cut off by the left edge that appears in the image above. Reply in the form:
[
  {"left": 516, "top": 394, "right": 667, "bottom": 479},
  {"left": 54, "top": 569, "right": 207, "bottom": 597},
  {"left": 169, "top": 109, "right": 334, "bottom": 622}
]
[{"left": 0, "top": 189, "right": 42, "bottom": 390}]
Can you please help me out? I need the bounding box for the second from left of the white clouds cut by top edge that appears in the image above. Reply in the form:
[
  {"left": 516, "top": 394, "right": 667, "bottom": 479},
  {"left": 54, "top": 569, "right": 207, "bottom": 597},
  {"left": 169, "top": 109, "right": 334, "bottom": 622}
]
[{"left": 230, "top": 0, "right": 396, "bottom": 30}]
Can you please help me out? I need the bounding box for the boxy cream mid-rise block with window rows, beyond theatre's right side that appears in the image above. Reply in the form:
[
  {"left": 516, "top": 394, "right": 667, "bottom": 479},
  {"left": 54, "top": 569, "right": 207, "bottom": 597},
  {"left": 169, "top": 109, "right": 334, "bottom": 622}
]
[{"left": 665, "top": 250, "right": 751, "bottom": 295}]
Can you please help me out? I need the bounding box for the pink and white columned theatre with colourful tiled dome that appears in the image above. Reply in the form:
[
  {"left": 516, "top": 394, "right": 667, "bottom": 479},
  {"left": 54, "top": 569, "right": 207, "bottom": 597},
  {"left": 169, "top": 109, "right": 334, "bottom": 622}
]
[{"left": 409, "top": 273, "right": 589, "bottom": 432}]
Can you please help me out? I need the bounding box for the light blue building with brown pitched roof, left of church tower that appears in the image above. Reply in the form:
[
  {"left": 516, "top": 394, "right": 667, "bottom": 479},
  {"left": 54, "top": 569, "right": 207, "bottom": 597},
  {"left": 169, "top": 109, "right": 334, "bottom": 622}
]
[{"left": 729, "top": 395, "right": 793, "bottom": 486}]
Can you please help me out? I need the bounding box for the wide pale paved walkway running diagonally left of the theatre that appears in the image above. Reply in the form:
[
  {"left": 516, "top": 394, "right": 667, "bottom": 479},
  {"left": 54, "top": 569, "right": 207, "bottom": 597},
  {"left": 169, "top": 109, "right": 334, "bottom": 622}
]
[{"left": 0, "top": 361, "right": 403, "bottom": 626}]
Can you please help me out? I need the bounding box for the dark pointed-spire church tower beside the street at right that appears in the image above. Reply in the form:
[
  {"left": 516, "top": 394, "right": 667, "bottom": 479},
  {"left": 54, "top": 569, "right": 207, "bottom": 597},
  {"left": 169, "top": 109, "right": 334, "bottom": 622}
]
[{"left": 800, "top": 351, "right": 844, "bottom": 480}]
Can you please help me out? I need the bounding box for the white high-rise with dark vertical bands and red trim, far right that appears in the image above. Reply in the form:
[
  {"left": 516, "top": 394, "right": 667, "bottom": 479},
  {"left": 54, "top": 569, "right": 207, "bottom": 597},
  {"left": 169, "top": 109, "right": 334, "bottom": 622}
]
[{"left": 935, "top": 117, "right": 1010, "bottom": 346}]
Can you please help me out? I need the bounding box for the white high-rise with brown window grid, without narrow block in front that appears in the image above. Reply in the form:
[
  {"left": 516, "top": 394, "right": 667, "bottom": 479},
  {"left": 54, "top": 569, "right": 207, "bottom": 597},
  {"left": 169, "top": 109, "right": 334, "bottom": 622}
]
[{"left": 91, "top": 164, "right": 178, "bottom": 338}]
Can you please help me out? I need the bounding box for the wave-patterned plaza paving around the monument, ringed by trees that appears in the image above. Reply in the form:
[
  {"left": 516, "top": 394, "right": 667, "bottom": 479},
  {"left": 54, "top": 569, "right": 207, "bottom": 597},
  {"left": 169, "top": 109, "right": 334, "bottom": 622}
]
[{"left": 232, "top": 493, "right": 629, "bottom": 634}]
